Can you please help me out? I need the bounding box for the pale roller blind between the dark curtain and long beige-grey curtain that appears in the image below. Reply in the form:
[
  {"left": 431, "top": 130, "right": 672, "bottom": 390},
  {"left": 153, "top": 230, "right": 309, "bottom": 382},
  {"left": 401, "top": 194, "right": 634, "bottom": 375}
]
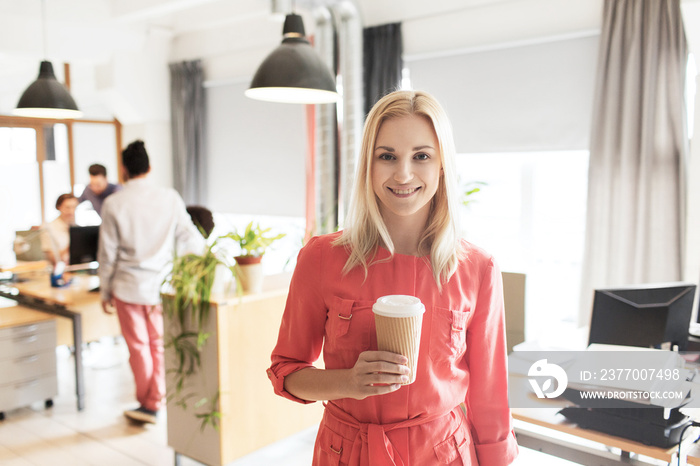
[{"left": 407, "top": 35, "right": 599, "bottom": 153}]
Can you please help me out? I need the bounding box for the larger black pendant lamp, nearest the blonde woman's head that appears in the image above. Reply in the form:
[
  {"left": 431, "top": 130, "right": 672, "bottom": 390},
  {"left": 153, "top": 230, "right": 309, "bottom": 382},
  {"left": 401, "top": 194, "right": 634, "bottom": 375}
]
[{"left": 245, "top": 14, "right": 339, "bottom": 104}]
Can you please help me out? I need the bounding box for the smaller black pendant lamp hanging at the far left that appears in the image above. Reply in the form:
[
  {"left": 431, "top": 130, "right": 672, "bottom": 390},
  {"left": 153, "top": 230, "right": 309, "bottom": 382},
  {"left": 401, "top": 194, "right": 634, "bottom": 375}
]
[{"left": 12, "top": 61, "right": 83, "bottom": 118}]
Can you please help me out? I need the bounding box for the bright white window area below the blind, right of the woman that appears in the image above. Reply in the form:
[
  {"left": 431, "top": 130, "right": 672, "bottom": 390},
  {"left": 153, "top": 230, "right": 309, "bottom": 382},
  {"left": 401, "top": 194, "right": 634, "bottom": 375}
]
[{"left": 457, "top": 151, "right": 588, "bottom": 339}]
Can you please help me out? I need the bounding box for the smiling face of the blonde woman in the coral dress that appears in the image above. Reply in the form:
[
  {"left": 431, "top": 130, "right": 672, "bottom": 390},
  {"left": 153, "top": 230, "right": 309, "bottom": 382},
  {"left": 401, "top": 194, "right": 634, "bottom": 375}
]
[{"left": 371, "top": 115, "right": 442, "bottom": 226}]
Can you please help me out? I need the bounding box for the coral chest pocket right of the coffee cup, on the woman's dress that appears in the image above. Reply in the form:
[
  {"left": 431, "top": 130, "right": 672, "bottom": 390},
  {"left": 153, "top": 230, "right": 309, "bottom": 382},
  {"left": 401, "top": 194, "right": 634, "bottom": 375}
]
[{"left": 429, "top": 306, "right": 471, "bottom": 362}]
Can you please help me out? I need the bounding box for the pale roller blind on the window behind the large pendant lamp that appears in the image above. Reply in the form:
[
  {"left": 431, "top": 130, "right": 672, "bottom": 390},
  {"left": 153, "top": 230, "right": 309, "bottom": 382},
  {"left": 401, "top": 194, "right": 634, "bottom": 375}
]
[{"left": 206, "top": 81, "right": 306, "bottom": 217}]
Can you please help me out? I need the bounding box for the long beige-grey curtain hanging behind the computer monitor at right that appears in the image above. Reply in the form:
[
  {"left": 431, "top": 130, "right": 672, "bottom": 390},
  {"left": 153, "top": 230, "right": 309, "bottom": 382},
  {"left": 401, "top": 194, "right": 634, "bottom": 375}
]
[{"left": 579, "top": 0, "right": 688, "bottom": 325}]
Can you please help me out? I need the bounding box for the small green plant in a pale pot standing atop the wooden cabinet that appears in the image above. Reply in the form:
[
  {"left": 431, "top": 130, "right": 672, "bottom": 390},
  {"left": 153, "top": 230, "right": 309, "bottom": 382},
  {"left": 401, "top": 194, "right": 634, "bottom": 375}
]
[{"left": 220, "top": 221, "right": 285, "bottom": 293}]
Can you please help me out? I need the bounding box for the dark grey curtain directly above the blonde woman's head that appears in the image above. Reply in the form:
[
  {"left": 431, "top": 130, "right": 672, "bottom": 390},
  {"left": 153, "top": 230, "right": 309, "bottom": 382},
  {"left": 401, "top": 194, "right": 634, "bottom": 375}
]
[{"left": 363, "top": 23, "right": 403, "bottom": 115}]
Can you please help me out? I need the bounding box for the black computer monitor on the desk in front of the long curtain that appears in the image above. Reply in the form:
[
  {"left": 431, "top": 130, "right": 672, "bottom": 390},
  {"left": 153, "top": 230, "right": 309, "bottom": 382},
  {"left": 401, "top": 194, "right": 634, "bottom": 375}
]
[{"left": 588, "top": 282, "right": 697, "bottom": 351}]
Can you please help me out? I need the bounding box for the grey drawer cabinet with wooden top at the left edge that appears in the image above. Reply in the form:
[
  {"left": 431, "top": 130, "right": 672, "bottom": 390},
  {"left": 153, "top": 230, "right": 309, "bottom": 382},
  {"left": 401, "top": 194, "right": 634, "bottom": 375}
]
[{"left": 0, "top": 306, "right": 58, "bottom": 419}]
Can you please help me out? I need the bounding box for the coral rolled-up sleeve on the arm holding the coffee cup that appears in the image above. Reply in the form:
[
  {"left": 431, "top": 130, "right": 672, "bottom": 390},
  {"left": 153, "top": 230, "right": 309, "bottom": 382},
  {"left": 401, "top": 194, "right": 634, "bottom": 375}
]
[{"left": 267, "top": 238, "right": 327, "bottom": 403}]
